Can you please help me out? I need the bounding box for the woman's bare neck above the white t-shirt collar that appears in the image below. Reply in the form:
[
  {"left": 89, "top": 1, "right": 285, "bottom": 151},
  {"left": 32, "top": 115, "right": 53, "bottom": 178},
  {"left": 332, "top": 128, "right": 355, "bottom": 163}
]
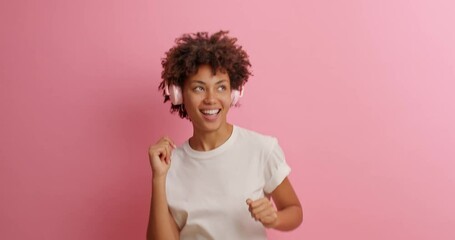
[{"left": 188, "top": 123, "right": 233, "bottom": 151}]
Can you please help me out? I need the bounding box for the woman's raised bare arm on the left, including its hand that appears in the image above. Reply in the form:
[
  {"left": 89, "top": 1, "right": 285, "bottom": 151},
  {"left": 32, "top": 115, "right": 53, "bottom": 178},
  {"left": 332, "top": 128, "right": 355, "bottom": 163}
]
[{"left": 147, "top": 137, "right": 179, "bottom": 240}]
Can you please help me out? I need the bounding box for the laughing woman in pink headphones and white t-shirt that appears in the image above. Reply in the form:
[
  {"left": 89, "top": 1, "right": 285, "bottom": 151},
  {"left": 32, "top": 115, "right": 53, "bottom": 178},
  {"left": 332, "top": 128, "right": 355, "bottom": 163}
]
[{"left": 147, "top": 31, "right": 303, "bottom": 240}]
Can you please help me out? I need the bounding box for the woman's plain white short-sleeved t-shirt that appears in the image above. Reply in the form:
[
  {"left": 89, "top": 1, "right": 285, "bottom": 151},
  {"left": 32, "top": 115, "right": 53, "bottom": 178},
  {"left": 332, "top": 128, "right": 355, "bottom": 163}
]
[{"left": 166, "top": 126, "right": 291, "bottom": 240}]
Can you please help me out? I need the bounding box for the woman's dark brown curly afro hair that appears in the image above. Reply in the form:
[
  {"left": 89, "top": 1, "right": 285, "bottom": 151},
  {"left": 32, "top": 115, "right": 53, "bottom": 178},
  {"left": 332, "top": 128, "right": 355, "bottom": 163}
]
[{"left": 158, "top": 31, "right": 252, "bottom": 118}]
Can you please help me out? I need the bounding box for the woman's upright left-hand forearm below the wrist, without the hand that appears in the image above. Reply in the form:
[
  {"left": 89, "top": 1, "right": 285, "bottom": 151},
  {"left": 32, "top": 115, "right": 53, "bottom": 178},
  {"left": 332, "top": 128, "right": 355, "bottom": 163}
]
[{"left": 147, "top": 178, "right": 179, "bottom": 240}]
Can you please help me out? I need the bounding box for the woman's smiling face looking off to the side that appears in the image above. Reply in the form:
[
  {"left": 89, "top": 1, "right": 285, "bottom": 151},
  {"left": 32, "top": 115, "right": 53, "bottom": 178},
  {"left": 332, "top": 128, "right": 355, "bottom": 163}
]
[{"left": 183, "top": 65, "right": 231, "bottom": 132}]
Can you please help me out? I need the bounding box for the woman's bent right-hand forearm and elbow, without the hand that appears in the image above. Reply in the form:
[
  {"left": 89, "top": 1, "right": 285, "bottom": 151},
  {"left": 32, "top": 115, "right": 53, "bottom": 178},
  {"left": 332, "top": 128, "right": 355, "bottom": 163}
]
[{"left": 273, "top": 206, "right": 303, "bottom": 231}]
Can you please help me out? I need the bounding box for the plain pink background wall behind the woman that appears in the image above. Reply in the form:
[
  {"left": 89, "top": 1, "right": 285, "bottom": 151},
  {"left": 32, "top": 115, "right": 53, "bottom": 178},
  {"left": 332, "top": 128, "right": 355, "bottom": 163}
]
[{"left": 0, "top": 0, "right": 455, "bottom": 240}]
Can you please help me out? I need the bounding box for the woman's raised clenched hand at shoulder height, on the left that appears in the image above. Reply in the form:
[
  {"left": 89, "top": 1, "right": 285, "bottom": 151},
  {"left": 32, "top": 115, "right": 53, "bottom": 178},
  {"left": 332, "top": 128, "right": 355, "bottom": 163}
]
[{"left": 148, "top": 137, "right": 176, "bottom": 178}]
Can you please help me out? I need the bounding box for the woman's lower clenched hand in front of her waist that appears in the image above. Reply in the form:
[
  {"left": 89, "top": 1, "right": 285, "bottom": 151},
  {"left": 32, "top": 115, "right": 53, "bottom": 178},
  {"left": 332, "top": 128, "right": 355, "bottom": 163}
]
[{"left": 246, "top": 197, "right": 278, "bottom": 228}]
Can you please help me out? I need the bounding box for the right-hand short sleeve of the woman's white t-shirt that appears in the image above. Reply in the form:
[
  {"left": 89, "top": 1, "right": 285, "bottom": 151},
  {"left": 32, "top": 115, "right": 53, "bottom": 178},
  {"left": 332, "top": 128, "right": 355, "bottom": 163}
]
[{"left": 264, "top": 138, "right": 291, "bottom": 194}]
